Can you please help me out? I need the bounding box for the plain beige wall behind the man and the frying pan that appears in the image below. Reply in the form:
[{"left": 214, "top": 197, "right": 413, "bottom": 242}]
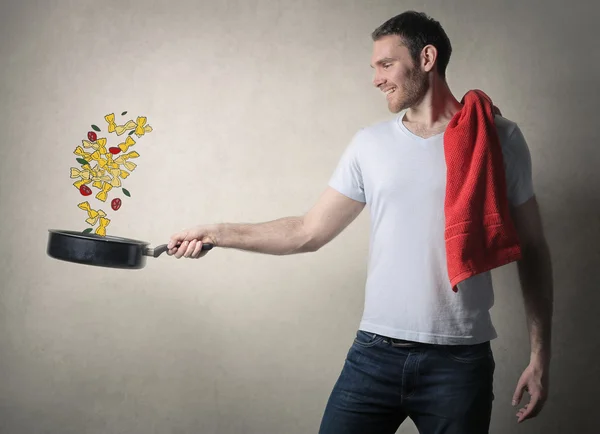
[{"left": 0, "top": 0, "right": 600, "bottom": 434}]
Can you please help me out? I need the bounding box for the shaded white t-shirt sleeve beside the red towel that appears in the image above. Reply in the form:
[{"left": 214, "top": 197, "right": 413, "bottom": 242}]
[{"left": 504, "top": 126, "right": 534, "bottom": 206}]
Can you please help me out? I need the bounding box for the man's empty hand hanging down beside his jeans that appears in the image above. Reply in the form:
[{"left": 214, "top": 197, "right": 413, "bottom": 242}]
[{"left": 512, "top": 360, "right": 549, "bottom": 423}]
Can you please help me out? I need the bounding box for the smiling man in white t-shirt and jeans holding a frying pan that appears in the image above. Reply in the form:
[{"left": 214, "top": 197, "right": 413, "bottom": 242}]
[{"left": 169, "top": 12, "right": 552, "bottom": 434}]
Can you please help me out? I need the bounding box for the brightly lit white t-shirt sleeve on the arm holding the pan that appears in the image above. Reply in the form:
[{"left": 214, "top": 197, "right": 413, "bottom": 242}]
[{"left": 329, "top": 131, "right": 366, "bottom": 202}]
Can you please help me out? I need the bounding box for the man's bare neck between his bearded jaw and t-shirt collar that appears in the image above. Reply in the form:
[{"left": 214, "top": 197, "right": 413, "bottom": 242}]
[{"left": 402, "top": 78, "right": 462, "bottom": 130}]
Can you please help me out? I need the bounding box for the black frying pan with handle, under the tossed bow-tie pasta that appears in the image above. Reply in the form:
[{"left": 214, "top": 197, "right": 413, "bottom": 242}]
[{"left": 46, "top": 229, "right": 213, "bottom": 269}]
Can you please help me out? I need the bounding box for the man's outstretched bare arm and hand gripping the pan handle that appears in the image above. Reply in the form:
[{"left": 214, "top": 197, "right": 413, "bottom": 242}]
[{"left": 169, "top": 187, "right": 365, "bottom": 257}]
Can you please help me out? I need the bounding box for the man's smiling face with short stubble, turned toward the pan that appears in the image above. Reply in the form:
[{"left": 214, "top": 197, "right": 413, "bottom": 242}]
[{"left": 371, "top": 35, "right": 429, "bottom": 113}]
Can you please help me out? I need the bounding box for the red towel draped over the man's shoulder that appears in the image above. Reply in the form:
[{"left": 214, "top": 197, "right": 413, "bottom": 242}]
[{"left": 444, "top": 90, "right": 521, "bottom": 292}]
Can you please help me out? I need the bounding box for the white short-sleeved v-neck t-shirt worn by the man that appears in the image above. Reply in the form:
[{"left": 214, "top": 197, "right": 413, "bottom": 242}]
[{"left": 329, "top": 111, "right": 534, "bottom": 345}]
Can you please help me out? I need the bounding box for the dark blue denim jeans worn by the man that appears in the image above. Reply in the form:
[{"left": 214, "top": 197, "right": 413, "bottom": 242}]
[{"left": 319, "top": 330, "right": 495, "bottom": 434}]
